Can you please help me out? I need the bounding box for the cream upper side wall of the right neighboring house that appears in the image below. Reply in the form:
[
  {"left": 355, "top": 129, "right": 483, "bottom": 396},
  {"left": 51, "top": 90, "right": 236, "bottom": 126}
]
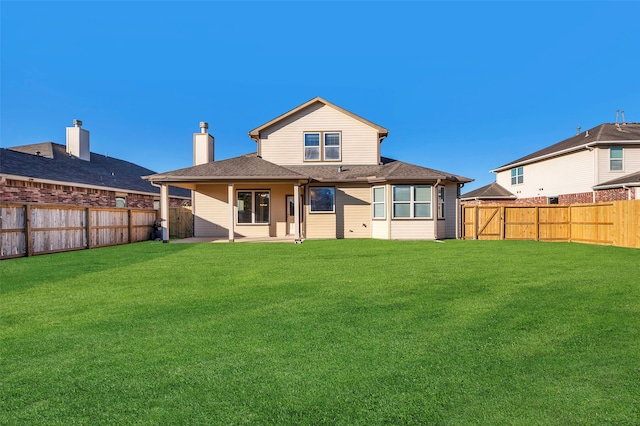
[{"left": 496, "top": 149, "right": 597, "bottom": 198}]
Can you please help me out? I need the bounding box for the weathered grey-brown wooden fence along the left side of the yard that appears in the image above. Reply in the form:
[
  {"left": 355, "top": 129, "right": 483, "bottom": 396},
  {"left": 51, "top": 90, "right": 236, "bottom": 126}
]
[{"left": 0, "top": 204, "right": 157, "bottom": 259}]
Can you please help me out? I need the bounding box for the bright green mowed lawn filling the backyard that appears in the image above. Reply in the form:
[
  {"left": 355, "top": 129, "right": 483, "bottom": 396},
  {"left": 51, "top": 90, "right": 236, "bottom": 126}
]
[{"left": 0, "top": 240, "right": 640, "bottom": 425}]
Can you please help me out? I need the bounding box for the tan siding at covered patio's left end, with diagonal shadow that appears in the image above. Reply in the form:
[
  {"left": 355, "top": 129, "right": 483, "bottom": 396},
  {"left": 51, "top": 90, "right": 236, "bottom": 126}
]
[{"left": 193, "top": 185, "right": 229, "bottom": 237}]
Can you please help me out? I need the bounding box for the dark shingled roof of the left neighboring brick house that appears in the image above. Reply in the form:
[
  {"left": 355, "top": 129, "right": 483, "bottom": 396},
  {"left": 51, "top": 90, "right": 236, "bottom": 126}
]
[{"left": 0, "top": 142, "right": 191, "bottom": 197}]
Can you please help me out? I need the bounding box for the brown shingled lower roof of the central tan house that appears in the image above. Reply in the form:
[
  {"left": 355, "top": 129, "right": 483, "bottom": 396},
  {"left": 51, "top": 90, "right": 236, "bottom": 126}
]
[{"left": 145, "top": 153, "right": 473, "bottom": 183}]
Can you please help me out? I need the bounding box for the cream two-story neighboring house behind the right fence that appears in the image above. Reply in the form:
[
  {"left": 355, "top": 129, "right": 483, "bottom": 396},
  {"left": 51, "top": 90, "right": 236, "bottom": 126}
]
[{"left": 460, "top": 120, "right": 640, "bottom": 204}]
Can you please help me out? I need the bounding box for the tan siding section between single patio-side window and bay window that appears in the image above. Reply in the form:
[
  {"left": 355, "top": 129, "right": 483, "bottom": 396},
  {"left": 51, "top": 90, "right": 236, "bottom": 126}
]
[{"left": 336, "top": 185, "right": 371, "bottom": 238}]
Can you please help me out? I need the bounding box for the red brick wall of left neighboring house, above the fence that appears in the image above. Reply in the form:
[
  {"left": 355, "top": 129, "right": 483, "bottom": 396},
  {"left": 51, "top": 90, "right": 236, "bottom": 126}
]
[{"left": 0, "top": 179, "right": 191, "bottom": 209}]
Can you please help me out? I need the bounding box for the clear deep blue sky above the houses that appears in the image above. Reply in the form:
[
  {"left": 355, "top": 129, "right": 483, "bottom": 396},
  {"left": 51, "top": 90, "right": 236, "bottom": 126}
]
[{"left": 0, "top": 1, "right": 640, "bottom": 192}]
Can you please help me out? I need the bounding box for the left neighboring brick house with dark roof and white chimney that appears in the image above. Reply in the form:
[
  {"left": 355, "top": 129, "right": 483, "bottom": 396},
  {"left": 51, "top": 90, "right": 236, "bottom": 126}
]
[{"left": 0, "top": 120, "right": 191, "bottom": 209}]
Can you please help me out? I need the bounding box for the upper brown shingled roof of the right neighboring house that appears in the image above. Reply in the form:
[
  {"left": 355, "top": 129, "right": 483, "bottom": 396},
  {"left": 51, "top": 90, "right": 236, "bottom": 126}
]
[{"left": 492, "top": 123, "right": 640, "bottom": 172}]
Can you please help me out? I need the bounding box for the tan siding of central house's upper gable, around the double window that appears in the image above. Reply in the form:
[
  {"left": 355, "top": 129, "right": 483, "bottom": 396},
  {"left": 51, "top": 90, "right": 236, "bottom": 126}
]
[{"left": 260, "top": 104, "right": 379, "bottom": 165}]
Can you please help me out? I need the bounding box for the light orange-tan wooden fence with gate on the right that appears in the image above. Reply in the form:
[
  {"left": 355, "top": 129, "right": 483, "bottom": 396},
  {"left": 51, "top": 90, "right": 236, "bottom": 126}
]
[{"left": 462, "top": 200, "right": 640, "bottom": 248}]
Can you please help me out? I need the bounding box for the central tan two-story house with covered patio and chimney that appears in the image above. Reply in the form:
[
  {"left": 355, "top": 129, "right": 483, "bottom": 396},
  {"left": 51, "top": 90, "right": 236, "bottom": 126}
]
[{"left": 146, "top": 97, "right": 471, "bottom": 241}]
